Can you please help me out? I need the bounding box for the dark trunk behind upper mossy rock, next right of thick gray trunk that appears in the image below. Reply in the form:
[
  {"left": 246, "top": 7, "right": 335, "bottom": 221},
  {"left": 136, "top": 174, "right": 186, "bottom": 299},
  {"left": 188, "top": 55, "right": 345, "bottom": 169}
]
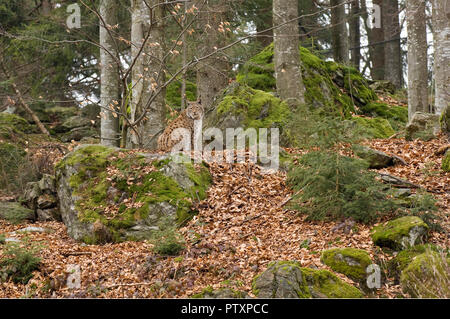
[{"left": 330, "top": 0, "right": 349, "bottom": 64}]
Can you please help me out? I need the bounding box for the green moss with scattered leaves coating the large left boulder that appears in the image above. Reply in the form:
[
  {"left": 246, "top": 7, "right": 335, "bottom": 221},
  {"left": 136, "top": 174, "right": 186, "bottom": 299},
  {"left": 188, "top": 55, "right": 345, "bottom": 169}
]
[{"left": 56, "top": 145, "right": 211, "bottom": 243}]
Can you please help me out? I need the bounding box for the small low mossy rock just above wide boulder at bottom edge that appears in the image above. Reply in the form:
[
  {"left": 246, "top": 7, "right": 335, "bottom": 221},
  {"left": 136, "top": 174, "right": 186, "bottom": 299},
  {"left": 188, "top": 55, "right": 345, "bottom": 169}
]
[{"left": 320, "top": 248, "right": 373, "bottom": 282}]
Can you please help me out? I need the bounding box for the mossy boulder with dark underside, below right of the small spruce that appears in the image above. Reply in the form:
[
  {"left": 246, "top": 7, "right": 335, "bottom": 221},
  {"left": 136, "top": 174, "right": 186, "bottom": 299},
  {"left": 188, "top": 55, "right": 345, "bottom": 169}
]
[{"left": 371, "top": 216, "right": 428, "bottom": 251}]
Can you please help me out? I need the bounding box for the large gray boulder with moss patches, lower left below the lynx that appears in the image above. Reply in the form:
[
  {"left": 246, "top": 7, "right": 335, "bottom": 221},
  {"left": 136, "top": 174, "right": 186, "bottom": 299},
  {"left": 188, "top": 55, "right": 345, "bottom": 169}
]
[{"left": 56, "top": 145, "right": 211, "bottom": 243}]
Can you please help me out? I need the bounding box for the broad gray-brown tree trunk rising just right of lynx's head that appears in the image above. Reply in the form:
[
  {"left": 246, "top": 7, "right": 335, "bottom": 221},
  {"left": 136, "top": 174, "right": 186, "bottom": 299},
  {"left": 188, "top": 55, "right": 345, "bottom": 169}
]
[{"left": 197, "top": 0, "right": 230, "bottom": 110}]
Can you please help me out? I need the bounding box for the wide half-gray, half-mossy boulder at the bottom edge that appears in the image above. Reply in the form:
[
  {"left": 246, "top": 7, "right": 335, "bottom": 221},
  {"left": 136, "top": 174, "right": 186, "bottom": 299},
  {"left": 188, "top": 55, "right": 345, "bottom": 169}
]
[{"left": 252, "top": 261, "right": 363, "bottom": 298}]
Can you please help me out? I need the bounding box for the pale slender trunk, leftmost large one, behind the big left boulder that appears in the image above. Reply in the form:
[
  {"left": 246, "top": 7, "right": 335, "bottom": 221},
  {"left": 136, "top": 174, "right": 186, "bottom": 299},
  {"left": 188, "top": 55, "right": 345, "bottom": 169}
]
[{"left": 100, "top": 0, "right": 120, "bottom": 146}]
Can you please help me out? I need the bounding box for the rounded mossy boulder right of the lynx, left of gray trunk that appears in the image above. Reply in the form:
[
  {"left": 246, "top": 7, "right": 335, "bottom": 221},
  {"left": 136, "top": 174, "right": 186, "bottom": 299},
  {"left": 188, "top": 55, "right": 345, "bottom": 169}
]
[{"left": 203, "top": 82, "right": 290, "bottom": 133}]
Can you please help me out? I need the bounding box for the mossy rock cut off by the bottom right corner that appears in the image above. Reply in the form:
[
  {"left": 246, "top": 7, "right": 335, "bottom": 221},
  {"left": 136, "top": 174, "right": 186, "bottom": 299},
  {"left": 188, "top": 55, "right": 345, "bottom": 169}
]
[{"left": 400, "top": 250, "right": 450, "bottom": 298}]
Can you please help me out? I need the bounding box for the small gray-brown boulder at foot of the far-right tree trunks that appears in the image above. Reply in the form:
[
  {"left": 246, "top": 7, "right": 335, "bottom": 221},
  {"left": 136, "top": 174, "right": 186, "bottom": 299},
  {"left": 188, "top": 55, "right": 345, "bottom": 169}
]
[{"left": 405, "top": 112, "right": 440, "bottom": 141}]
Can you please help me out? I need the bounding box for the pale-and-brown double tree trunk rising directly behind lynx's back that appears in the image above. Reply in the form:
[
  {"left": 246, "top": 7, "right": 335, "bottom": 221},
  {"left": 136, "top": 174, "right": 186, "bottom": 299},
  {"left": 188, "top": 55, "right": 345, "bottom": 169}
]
[{"left": 129, "top": 0, "right": 166, "bottom": 149}]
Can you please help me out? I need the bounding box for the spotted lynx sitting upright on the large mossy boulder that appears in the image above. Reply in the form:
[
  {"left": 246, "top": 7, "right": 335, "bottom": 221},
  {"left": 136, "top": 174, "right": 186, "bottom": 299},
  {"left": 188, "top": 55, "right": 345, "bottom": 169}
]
[{"left": 158, "top": 102, "right": 204, "bottom": 152}]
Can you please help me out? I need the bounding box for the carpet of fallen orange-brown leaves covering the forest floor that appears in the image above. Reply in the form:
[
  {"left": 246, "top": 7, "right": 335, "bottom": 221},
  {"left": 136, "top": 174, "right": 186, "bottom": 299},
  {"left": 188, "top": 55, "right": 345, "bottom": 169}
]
[{"left": 0, "top": 131, "right": 450, "bottom": 298}]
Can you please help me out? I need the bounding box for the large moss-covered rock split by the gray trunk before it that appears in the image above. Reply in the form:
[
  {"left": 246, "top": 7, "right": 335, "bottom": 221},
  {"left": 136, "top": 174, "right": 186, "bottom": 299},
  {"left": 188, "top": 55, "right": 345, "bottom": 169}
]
[{"left": 237, "top": 44, "right": 377, "bottom": 116}]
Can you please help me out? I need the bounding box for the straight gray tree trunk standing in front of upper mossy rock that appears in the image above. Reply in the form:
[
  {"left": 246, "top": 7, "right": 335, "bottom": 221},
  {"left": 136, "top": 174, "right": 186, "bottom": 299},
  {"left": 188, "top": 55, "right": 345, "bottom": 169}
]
[{"left": 273, "top": 0, "right": 305, "bottom": 105}]
